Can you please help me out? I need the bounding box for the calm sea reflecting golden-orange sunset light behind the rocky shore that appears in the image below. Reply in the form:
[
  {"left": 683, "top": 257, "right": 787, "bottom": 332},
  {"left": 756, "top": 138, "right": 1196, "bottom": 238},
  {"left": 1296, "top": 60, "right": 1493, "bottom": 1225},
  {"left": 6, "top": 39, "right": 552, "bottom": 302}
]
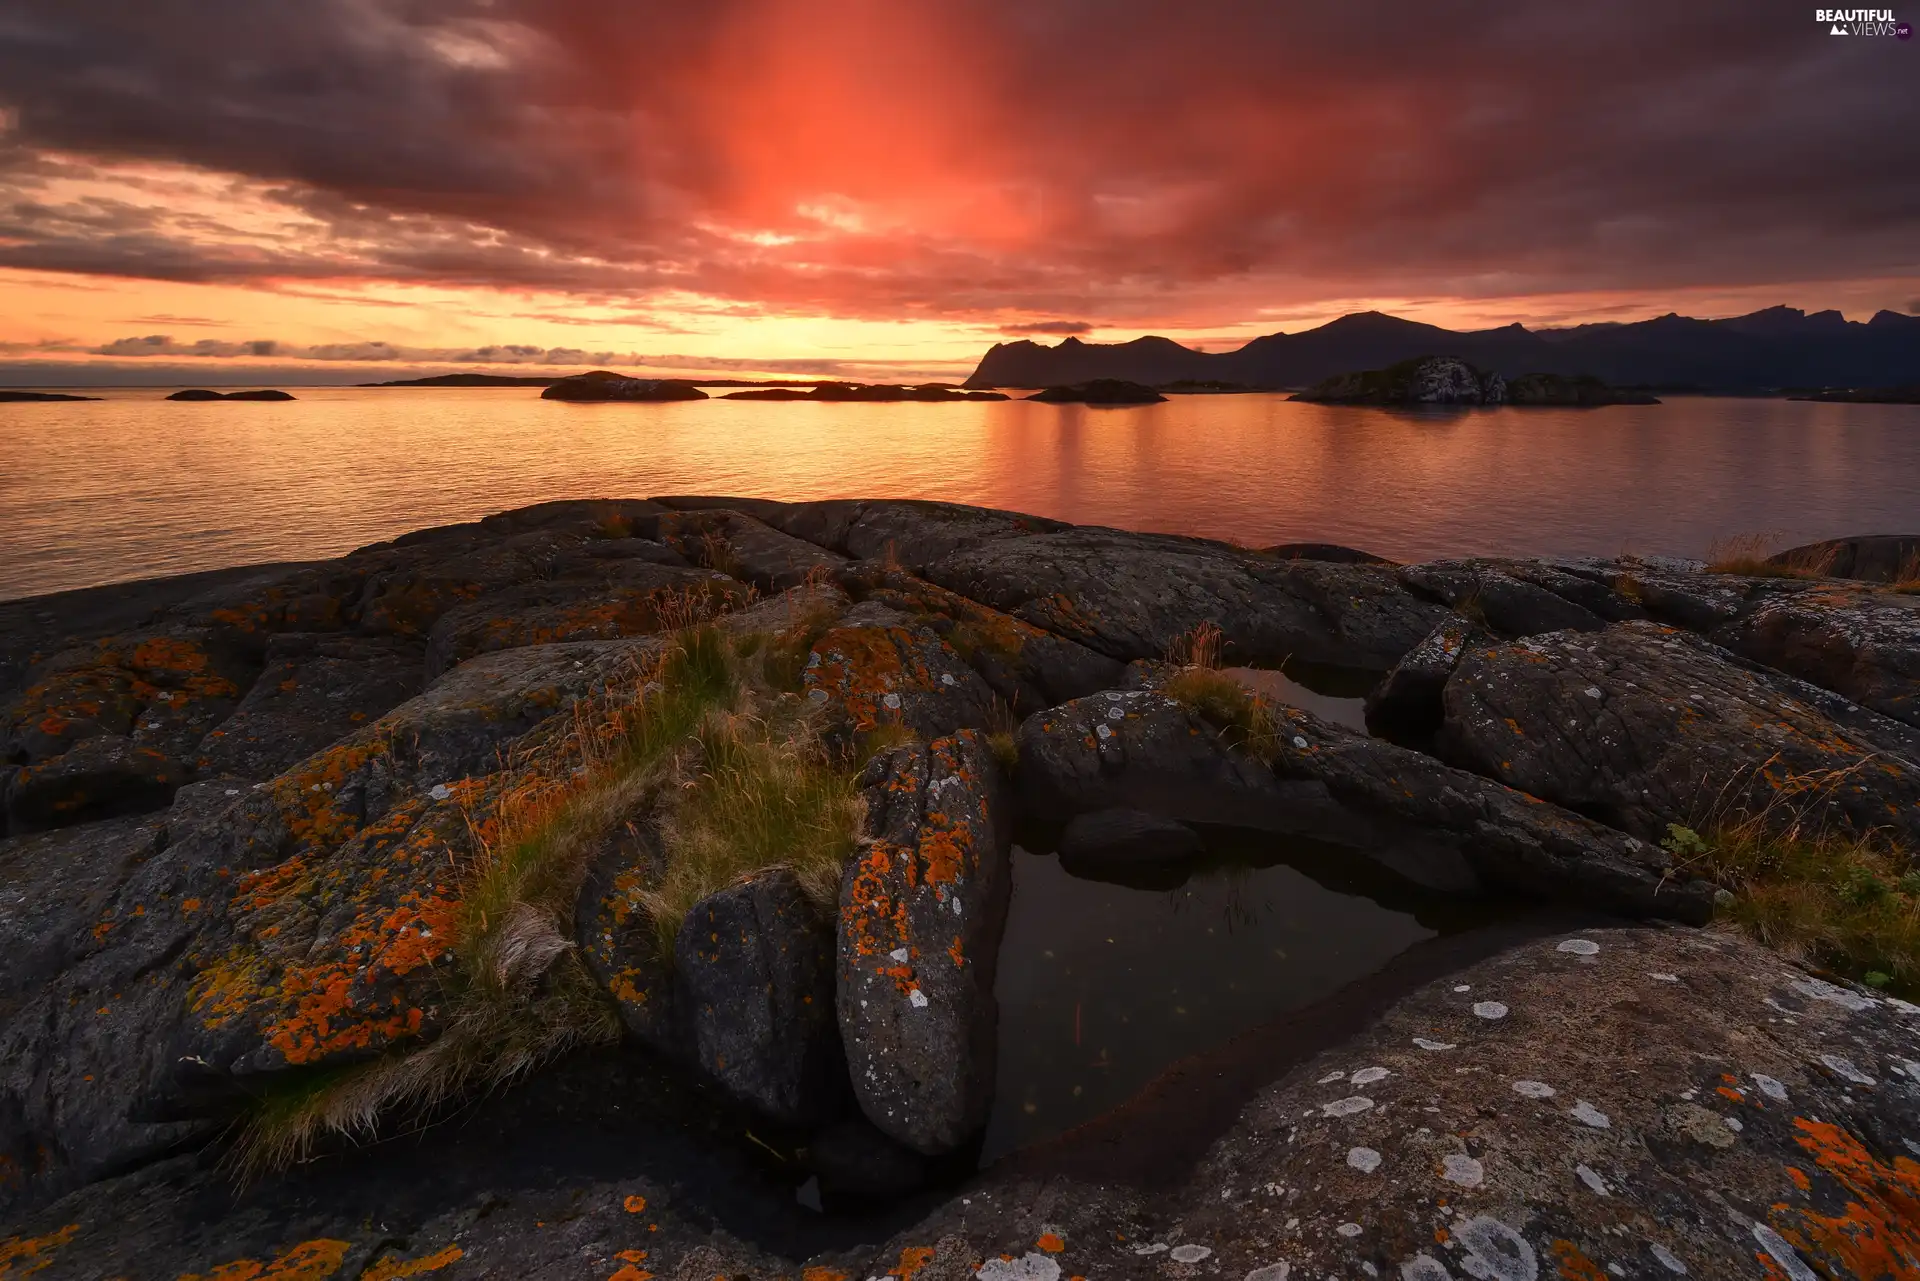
[{"left": 0, "top": 388, "right": 1920, "bottom": 599}]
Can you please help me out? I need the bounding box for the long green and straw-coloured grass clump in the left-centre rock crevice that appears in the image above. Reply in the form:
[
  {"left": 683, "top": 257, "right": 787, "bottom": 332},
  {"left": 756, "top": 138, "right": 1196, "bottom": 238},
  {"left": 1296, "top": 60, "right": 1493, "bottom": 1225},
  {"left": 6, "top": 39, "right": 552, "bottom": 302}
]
[{"left": 230, "top": 618, "right": 860, "bottom": 1173}]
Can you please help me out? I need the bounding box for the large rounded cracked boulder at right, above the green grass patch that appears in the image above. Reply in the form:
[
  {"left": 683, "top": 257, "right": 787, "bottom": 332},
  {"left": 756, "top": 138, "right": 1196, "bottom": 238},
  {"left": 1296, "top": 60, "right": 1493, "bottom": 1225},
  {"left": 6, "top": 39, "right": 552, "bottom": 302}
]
[{"left": 1442, "top": 622, "right": 1920, "bottom": 843}]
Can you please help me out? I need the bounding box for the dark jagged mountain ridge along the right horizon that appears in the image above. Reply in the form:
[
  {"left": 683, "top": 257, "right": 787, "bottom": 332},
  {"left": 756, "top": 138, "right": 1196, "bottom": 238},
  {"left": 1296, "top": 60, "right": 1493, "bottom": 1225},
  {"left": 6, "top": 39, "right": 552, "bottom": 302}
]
[{"left": 966, "top": 307, "right": 1920, "bottom": 392}]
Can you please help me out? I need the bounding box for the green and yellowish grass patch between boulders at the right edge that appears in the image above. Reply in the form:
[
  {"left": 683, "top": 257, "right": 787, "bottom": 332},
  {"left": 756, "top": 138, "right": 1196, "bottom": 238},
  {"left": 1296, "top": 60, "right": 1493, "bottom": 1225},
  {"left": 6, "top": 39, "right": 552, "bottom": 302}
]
[{"left": 1663, "top": 822, "right": 1920, "bottom": 999}]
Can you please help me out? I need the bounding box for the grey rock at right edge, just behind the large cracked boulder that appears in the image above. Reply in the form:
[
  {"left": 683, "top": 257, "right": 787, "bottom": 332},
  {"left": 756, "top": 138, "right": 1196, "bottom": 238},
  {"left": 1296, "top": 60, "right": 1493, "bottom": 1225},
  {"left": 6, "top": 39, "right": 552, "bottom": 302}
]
[{"left": 1713, "top": 586, "right": 1920, "bottom": 726}]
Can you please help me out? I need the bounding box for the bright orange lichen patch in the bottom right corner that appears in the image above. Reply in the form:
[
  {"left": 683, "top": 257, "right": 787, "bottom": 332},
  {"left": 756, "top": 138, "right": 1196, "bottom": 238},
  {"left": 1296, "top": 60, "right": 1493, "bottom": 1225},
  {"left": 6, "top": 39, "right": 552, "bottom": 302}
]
[{"left": 1776, "top": 1118, "right": 1920, "bottom": 1279}]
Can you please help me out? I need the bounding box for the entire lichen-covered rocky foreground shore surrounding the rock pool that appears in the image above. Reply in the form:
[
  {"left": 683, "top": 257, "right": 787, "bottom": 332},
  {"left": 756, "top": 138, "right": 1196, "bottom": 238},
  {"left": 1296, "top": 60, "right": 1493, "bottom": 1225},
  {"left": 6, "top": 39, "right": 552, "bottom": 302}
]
[{"left": 0, "top": 495, "right": 1920, "bottom": 1281}]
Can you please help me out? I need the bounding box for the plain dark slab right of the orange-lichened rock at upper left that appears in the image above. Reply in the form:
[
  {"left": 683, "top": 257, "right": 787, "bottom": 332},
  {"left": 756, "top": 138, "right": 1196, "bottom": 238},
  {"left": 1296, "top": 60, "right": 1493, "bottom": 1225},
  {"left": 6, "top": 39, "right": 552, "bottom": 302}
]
[{"left": 194, "top": 632, "right": 422, "bottom": 780}]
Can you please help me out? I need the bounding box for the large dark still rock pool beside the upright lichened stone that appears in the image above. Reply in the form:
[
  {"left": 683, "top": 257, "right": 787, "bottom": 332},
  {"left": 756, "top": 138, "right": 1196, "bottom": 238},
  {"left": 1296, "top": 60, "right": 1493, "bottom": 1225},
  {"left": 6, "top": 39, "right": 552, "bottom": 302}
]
[{"left": 981, "top": 832, "right": 1500, "bottom": 1164}]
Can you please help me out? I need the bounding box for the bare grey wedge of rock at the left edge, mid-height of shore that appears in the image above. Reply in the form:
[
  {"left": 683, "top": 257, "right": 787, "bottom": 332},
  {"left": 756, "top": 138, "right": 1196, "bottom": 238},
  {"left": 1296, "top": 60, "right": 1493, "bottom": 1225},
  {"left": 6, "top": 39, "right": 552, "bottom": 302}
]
[{"left": 0, "top": 816, "right": 161, "bottom": 1020}]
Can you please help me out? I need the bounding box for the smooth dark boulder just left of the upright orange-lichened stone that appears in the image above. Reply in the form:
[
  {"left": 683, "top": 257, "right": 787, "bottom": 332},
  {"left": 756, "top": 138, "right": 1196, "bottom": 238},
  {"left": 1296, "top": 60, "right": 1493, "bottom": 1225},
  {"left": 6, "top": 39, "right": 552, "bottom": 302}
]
[{"left": 674, "top": 868, "right": 847, "bottom": 1125}]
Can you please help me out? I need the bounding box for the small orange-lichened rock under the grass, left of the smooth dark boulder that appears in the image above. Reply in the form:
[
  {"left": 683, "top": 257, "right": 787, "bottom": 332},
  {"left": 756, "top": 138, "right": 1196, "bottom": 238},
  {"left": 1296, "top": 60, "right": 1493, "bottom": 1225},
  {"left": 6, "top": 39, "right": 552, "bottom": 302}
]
[{"left": 574, "top": 812, "right": 687, "bottom": 1058}]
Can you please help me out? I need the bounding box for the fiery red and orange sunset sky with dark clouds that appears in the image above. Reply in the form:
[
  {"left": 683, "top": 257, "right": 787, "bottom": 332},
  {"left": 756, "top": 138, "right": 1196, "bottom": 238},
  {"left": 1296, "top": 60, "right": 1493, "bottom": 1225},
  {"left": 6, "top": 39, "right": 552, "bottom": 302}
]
[{"left": 0, "top": 0, "right": 1920, "bottom": 384}]
